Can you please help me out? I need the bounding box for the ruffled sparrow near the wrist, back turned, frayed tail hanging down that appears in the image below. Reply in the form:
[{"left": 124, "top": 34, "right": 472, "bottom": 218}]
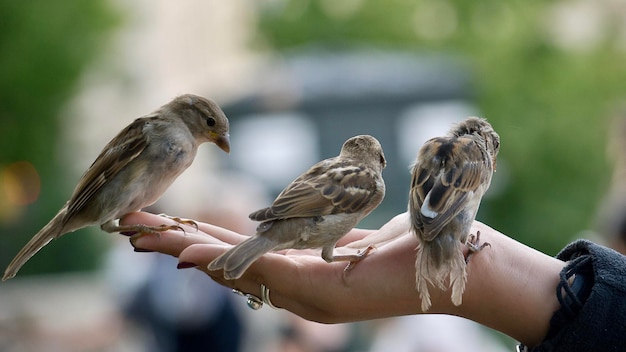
[{"left": 409, "top": 117, "right": 500, "bottom": 312}]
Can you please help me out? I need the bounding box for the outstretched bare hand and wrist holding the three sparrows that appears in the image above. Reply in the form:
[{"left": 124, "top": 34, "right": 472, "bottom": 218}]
[{"left": 121, "top": 213, "right": 564, "bottom": 346}]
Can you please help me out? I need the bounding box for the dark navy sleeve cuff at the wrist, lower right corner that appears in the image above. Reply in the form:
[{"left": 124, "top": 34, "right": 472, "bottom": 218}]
[{"left": 532, "top": 240, "right": 626, "bottom": 352}]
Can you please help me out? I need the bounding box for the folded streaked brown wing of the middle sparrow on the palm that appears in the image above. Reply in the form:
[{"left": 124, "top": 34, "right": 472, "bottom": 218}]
[{"left": 250, "top": 158, "right": 382, "bottom": 221}]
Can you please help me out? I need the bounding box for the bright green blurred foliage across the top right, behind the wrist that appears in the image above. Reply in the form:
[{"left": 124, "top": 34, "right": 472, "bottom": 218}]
[{"left": 252, "top": 0, "right": 626, "bottom": 254}]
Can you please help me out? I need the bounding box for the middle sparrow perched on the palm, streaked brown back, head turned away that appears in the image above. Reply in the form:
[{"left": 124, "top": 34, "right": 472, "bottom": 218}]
[{"left": 208, "top": 135, "right": 387, "bottom": 280}]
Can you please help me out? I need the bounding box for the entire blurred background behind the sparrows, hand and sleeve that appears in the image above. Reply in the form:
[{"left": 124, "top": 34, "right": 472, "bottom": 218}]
[{"left": 0, "top": 0, "right": 626, "bottom": 351}]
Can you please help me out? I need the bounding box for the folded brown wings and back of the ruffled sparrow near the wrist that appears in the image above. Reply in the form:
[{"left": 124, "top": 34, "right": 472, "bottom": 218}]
[{"left": 411, "top": 136, "right": 491, "bottom": 240}]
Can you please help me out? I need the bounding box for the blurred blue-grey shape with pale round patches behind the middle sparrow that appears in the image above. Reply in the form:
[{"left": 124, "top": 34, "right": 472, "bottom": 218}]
[{"left": 224, "top": 47, "right": 476, "bottom": 225}]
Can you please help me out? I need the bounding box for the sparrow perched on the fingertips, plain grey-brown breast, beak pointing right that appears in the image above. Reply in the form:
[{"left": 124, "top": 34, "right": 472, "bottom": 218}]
[{"left": 2, "top": 94, "right": 230, "bottom": 281}]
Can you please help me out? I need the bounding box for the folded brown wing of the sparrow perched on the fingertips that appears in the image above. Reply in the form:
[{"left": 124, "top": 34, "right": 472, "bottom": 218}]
[{"left": 66, "top": 117, "right": 148, "bottom": 221}]
